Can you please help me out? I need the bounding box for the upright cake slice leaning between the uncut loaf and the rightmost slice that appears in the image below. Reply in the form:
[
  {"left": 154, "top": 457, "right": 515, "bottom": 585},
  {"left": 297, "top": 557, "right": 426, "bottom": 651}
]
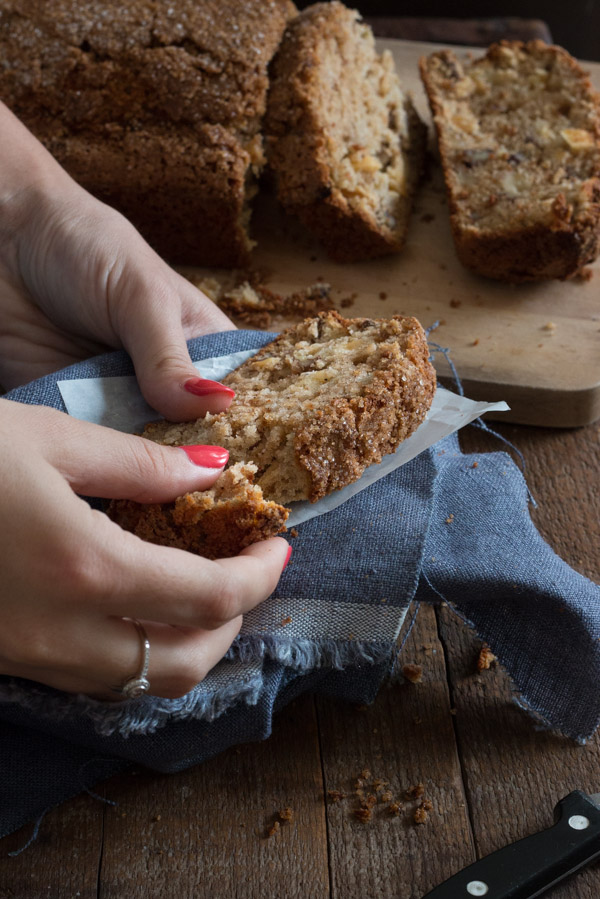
[{"left": 265, "top": 0, "right": 426, "bottom": 262}]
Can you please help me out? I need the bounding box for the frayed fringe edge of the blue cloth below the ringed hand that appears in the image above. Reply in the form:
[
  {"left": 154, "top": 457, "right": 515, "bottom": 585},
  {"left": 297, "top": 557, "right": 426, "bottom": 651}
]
[{"left": 0, "top": 636, "right": 395, "bottom": 738}]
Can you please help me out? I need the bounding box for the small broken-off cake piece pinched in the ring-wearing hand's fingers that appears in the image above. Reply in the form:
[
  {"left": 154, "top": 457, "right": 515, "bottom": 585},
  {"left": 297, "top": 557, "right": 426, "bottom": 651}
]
[{"left": 108, "top": 463, "right": 289, "bottom": 559}]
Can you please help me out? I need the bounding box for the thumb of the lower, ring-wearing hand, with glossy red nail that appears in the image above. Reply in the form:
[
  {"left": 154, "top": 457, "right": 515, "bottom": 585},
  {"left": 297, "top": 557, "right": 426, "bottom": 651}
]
[{"left": 44, "top": 413, "right": 229, "bottom": 503}]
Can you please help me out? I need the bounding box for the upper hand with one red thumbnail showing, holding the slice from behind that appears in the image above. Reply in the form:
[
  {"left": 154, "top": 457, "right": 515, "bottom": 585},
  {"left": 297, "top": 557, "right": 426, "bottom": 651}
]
[{"left": 0, "top": 103, "right": 233, "bottom": 421}]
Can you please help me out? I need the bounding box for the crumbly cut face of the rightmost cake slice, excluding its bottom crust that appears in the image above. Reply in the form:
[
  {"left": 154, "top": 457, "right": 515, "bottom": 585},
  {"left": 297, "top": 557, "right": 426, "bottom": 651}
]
[{"left": 425, "top": 42, "right": 600, "bottom": 233}]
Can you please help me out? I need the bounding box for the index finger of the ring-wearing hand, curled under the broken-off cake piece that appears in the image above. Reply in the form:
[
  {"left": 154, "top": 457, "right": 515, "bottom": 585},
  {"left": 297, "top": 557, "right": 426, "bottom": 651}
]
[{"left": 95, "top": 532, "right": 289, "bottom": 630}]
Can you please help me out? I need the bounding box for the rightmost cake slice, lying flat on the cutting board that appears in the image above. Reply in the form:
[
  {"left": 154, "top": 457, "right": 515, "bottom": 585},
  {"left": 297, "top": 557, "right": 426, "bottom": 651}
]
[{"left": 421, "top": 41, "right": 600, "bottom": 282}]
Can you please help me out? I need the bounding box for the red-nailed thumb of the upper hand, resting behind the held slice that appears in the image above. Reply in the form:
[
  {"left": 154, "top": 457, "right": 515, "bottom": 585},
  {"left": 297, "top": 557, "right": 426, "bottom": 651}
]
[{"left": 122, "top": 284, "right": 235, "bottom": 421}]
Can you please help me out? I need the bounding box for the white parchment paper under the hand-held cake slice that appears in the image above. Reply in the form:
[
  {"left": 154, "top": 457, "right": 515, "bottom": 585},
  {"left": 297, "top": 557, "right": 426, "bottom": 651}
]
[{"left": 58, "top": 350, "right": 509, "bottom": 527}]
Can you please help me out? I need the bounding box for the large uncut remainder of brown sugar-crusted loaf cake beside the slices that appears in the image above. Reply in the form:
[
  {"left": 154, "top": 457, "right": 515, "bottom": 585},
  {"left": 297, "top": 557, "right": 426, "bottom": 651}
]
[{"left": 0, "top": 0, "right": 295, "bottom": 266}]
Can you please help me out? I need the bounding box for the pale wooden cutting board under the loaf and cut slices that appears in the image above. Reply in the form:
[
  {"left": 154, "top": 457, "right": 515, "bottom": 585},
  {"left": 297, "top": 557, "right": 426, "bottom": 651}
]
[{"left": 198, "top": 40, "right": 600, "bottom": 427}]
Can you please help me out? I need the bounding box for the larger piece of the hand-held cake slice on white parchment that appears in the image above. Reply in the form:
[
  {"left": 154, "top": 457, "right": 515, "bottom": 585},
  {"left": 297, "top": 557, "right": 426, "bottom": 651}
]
[{"left": 145, "top": 312, "right": 435, "bottom": 503}]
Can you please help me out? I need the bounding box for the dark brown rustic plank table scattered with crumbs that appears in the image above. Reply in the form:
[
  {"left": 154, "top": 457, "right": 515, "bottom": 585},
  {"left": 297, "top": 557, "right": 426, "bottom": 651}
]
[{"left": 0, "top": 15, "right": 600, "bottom": 899}]
